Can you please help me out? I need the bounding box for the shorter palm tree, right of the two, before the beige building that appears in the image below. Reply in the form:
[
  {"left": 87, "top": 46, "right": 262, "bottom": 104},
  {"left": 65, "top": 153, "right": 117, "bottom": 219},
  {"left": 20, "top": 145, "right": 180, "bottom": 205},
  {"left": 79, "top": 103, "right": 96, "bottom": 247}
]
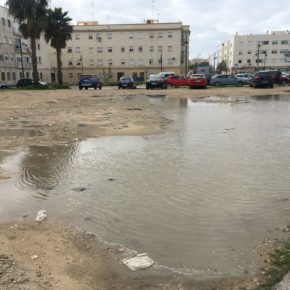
[{"left": 44, "top": 8, "right": 73, "bottom": 85}]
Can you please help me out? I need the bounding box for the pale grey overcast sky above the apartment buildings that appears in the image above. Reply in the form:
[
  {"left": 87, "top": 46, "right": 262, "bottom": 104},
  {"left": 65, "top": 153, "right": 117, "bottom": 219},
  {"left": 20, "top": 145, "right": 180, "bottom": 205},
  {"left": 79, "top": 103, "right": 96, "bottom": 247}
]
[{"left": 0, "top": 0, "right": 290, "bottom": 58}]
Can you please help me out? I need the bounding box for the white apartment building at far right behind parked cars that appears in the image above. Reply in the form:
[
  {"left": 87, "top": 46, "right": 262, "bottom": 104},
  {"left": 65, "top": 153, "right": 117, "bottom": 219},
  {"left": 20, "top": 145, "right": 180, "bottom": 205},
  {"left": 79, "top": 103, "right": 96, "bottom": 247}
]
[{"left": 215, "top": 30, "right": 290, "bottom": 73}]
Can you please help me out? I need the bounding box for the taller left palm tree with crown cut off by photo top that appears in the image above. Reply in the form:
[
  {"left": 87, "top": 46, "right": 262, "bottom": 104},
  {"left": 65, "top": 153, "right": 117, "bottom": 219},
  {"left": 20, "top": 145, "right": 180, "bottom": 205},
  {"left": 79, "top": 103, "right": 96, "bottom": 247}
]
[{"left": 6, "top": 0, "right": 48, "bottom": 82}]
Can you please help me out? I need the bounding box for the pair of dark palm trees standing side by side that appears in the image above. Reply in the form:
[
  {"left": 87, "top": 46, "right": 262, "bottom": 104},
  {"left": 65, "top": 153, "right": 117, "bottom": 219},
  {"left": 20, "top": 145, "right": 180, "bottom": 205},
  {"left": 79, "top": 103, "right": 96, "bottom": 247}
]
[{"left": 6, "top": 0, "right": 73, "bottom": 85}]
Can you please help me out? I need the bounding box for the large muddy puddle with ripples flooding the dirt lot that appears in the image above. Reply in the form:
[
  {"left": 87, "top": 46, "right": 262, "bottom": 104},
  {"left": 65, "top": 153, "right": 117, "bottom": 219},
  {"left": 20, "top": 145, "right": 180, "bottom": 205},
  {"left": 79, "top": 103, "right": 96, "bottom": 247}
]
[{"left": 0, "top": 96, "right": 290, "bottom": 276}]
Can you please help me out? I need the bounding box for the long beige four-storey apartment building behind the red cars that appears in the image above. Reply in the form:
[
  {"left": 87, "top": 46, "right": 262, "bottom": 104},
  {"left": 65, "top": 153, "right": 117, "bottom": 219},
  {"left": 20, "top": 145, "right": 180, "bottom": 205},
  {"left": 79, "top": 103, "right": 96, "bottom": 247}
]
[{"left": 59, "top": 20, "right": 190, "bottom": 84}]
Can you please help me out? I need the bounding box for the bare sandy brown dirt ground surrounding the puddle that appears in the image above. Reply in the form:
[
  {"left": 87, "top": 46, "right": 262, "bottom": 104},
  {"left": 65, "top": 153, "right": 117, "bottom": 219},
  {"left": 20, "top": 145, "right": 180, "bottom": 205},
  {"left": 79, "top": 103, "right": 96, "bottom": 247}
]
[{"left": 0, "top": 87, "right": 290, "bottom": 290}]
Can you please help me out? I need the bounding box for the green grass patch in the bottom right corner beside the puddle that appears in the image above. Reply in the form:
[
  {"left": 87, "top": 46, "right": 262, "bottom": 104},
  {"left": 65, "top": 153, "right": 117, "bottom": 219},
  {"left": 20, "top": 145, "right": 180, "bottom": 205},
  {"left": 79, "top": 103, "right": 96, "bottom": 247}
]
[{"left": 255, "top": 242, "right": 290, "bottom": 290}]
